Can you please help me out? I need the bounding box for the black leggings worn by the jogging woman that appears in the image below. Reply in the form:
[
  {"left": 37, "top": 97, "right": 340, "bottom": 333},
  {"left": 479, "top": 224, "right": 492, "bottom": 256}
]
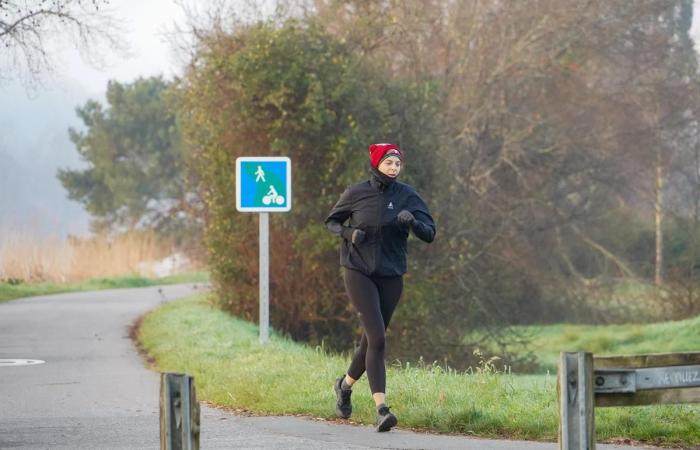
[{"left": 345, "top": 268, "right": 403, "bottom": 394}]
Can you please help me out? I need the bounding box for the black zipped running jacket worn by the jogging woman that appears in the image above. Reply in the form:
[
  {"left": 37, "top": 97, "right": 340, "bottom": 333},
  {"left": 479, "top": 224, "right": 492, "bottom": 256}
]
[{"left": 325, "top": 174, "right": 435, "bottom": 276}]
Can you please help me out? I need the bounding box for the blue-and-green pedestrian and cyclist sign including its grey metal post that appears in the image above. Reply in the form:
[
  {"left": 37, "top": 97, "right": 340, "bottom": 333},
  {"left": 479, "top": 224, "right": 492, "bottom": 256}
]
[{"left": 236, "top": 156, "right": 292, "bottom": 344}]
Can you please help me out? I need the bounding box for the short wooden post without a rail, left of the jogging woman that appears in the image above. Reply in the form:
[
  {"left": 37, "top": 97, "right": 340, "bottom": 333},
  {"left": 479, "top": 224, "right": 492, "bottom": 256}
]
[{"left": 160, "top": 373, "right": 200, "bottom": 450}]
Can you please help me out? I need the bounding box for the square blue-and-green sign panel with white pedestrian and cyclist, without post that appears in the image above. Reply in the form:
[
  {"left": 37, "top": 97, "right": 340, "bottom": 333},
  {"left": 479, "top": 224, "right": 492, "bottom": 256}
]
[{"left": 236, "top": 156, "right": 292, "bottom": 212}]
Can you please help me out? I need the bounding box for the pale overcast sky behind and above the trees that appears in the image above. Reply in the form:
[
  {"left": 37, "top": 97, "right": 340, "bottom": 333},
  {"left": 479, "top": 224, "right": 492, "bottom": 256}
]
[{"left": 0, "top": 0, "right": 700, "bottom": 239}]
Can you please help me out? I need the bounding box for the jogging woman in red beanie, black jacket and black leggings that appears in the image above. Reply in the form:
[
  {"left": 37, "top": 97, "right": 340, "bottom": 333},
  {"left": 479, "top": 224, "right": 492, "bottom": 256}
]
[{"left": 325, "top": 144, "right": 435, "bottom": 431}]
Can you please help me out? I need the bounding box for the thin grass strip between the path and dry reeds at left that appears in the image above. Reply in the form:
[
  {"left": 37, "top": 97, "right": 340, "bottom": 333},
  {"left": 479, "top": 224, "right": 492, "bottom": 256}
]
[{"left": 0, "top": 272, "right": 209, "bottom": 303}]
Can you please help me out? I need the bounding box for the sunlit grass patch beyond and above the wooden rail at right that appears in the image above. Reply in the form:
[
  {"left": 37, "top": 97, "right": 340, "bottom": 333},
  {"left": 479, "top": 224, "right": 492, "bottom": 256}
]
[{"left": 466, "top": 316, "right": 700, "bottom": 372}]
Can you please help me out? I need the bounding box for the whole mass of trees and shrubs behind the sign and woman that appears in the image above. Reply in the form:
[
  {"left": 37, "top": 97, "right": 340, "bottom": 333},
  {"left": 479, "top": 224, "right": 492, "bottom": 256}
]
[{"left": 61, "top": 0, "right": 700, "bottom": 367}]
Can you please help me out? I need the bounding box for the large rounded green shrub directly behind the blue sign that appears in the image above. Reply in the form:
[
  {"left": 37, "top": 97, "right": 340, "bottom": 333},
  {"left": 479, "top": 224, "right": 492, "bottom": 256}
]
[{"left": 179, "top": 21, "right": 438, "bottom": 349}]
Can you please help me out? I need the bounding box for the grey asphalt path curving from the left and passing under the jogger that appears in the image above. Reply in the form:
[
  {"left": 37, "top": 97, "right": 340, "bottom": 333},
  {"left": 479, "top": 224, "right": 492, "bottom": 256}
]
[{"left": 0, "top": 284, "right": 656, "bottom": 450}]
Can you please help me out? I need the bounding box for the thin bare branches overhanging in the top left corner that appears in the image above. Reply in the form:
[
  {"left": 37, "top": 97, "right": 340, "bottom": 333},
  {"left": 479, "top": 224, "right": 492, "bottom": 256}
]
[{"left": 0, "top": 0, "right": 126, "bottom": 88}]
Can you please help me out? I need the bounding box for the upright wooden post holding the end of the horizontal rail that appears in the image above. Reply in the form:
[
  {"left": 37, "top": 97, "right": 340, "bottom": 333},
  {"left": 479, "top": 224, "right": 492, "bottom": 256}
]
[{"left": 557, "top": 352, "right": 595, "bottom": 450}]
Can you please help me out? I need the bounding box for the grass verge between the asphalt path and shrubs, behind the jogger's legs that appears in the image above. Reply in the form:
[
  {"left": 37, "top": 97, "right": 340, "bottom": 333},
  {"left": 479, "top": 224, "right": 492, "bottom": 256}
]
[{"left": 139, "top": 295, "right": 700, "bottom": 446}]
